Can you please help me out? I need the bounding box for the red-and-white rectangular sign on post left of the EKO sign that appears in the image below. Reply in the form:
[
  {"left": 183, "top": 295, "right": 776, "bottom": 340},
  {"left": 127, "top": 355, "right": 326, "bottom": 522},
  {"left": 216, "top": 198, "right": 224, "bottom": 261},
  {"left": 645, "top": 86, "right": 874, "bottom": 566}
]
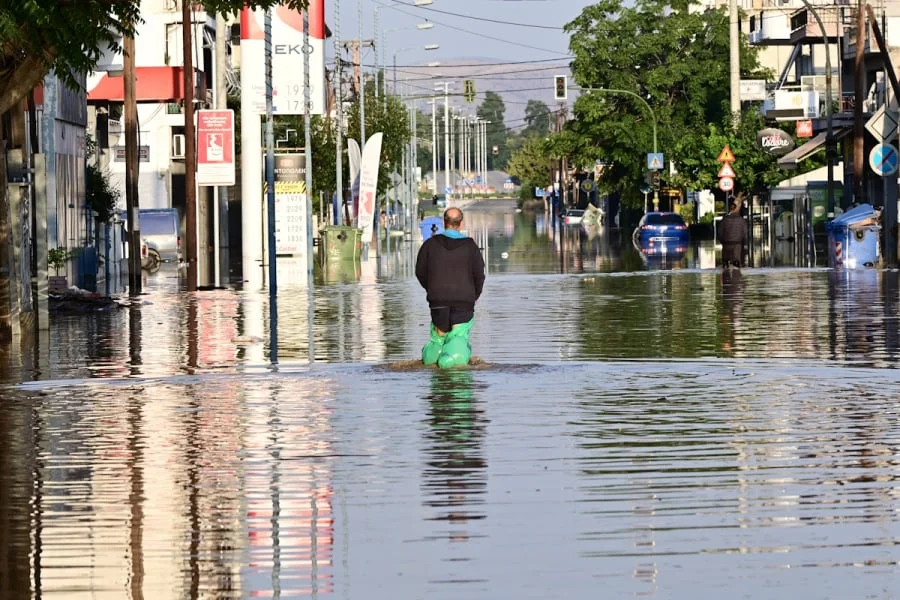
[{"left": 197, "top": 109, "right": 235, "bottom": 185}]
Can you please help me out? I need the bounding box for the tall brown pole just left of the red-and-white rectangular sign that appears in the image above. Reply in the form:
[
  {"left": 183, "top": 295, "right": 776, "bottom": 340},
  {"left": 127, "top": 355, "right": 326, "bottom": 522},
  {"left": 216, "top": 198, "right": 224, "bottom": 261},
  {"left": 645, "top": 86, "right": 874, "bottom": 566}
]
[{"left": 181, "top": 2, "right": 197, "bottom": 292}]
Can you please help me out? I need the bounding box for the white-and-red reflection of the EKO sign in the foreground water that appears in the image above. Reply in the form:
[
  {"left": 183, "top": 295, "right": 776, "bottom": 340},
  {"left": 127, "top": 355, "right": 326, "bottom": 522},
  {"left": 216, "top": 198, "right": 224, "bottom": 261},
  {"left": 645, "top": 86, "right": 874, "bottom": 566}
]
[{"left": 241, "top": 380, "right": 334, "bottom": 597}]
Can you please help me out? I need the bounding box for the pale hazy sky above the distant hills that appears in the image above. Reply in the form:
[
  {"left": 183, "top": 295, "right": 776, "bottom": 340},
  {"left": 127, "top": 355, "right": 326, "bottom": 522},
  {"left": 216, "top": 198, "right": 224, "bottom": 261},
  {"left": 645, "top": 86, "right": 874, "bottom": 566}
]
[{"left": 334, "top": 0, "right": 590, "bottom": 65}]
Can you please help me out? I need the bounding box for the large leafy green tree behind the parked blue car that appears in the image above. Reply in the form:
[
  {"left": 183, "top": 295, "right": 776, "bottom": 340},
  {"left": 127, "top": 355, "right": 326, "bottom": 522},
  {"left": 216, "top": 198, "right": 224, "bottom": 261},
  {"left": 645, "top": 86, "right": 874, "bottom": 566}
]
[{"left": 551, "top": 0, "right": 767, "bottom": 205}]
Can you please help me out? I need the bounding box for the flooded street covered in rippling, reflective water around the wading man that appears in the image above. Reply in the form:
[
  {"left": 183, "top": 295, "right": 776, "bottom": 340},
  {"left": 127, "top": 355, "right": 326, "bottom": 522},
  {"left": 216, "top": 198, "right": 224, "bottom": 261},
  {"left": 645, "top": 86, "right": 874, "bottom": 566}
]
[{"left": 0, "top": 203, "right": 900, "bottom": 600}]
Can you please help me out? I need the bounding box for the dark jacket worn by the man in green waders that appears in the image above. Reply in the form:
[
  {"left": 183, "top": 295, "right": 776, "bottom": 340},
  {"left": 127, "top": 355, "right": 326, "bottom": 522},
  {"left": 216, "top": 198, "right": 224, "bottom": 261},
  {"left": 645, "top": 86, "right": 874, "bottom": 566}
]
[{"left": 416, "top": 234, "right": 484, "bottom": 309}]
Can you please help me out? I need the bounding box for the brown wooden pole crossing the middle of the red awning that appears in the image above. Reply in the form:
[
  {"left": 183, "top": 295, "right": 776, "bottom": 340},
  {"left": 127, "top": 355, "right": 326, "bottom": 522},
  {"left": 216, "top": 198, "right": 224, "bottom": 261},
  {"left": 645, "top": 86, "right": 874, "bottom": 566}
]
[{"left": 122, "top": 34, "right": 141, "bottom": 296}]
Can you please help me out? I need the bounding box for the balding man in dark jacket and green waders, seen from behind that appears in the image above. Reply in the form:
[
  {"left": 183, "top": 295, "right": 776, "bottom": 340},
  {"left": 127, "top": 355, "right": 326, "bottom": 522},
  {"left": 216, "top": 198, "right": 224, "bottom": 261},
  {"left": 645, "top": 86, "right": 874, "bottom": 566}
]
[{"left": 416, "top": 208, "right": 484, "bottom": 369}]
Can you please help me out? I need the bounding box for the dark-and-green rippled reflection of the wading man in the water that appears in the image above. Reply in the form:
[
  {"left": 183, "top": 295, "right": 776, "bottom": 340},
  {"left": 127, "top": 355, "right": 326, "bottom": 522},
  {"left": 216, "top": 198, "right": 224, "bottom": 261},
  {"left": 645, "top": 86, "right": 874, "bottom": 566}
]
[{"left": 422, "top": 370, "right": 487, "bottom": 541}]
